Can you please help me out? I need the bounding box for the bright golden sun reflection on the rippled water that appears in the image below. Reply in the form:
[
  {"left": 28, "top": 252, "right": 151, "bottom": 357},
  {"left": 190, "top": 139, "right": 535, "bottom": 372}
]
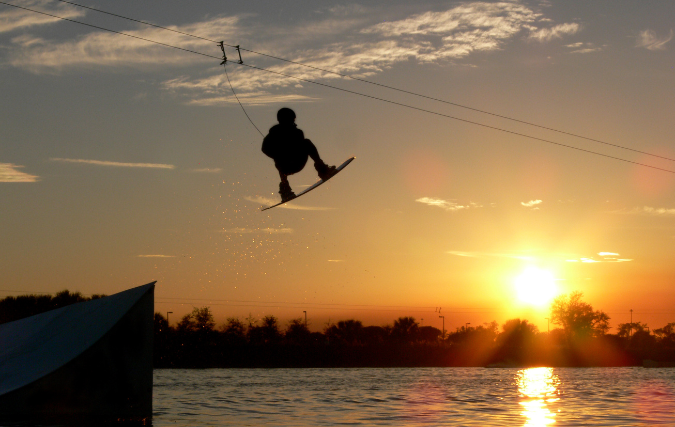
[{"left": 515, "top": 368, "right": 560, "bottom": 427}]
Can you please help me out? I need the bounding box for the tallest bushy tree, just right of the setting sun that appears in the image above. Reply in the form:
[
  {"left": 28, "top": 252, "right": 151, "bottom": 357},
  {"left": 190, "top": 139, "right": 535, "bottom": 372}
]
[{"left": 551, "top": 291, "right": 610, "bottom": 339}]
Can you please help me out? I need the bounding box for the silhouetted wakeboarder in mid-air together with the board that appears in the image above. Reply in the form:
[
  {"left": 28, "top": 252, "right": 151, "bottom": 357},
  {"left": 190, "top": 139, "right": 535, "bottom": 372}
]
[{"left": 262, "top": 107, "right": 354, "bottom": 210}]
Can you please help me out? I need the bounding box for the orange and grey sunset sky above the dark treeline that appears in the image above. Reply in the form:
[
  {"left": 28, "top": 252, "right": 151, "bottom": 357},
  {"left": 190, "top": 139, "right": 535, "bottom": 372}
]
[{"left": 0, "top": 0, "right": 675, "bottom": 331}]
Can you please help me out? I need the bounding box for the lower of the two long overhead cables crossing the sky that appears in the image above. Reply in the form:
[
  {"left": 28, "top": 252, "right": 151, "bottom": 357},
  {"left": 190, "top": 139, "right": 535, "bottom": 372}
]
[{"left": 0, "top": 0, "right": 675, "bottom": 174}]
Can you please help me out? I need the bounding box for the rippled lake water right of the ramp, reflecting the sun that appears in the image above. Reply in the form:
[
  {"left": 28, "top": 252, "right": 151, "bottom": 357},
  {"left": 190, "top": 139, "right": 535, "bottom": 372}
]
[{"left": 152, "top": 368, "right": 675, "bottom": 427}]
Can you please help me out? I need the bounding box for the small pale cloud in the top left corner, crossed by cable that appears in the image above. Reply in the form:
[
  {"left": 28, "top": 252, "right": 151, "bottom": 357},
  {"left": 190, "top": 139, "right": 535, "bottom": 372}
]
[{"left": 0, "top": 0, "right": 85, "bottom": 33}]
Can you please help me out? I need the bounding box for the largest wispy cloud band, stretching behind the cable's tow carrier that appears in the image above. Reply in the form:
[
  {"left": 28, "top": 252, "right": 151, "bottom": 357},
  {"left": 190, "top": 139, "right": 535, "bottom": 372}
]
[{"left": 8, "top": 2, "right": 579, "bottom": 106}]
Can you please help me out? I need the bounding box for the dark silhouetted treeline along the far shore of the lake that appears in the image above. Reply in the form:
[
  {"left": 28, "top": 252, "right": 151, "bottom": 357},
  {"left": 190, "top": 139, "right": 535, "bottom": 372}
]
[{"left": 5, "top": 291, "right": 675, "bottom": 368}]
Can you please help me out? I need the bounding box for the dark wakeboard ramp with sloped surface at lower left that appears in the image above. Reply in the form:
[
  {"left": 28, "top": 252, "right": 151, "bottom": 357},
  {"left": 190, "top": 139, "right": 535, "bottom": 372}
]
[{"left": 0, "top": 282, "right": 155, "bottom": 421}]
